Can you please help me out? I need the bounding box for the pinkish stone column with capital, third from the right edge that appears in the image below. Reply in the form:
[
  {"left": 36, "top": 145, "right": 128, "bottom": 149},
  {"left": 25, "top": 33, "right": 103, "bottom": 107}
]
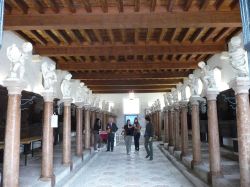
[{"left": 191, "top": 97, "right": 201, "bottom": 166}]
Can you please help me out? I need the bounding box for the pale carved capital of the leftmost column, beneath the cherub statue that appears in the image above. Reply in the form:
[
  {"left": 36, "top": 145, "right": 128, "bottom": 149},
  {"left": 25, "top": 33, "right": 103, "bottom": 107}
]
[{"left": 3, "top": 79, "right": 27, "bottom": 95}]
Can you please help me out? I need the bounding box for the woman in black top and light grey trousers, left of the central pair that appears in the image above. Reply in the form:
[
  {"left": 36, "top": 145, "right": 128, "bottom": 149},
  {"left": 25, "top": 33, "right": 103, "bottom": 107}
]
[{"left": 124, "top": 119, "right": 134, "bottom": 155}]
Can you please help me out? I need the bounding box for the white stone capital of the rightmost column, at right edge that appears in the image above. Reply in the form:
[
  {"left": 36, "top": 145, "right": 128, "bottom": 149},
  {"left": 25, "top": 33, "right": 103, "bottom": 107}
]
[{"left": 229, "top": 77, "right": 250, "bottom": 95}]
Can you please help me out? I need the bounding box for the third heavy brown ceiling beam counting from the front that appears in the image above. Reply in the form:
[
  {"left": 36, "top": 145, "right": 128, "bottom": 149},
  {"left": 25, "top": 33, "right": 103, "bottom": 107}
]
[{"left": 57, "top": 62, "right": 197, "bottom": 71}]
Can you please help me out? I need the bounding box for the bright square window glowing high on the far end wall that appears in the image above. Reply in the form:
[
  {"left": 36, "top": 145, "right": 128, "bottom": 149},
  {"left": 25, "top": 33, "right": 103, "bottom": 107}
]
[{"left": 123, "top": 98, "right": 140, "bottom": 114}]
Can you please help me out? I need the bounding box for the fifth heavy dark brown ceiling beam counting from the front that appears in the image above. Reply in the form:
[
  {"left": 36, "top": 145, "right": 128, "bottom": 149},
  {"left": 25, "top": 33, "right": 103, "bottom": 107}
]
[{"left": 83, "top": 78, "right": 183, "bottom": 86}]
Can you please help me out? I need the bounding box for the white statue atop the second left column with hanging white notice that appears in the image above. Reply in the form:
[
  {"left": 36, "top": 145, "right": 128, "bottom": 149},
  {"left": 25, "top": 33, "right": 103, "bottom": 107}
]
[{"left": 41, "top": 62, "right": 57, "bottom": 92}]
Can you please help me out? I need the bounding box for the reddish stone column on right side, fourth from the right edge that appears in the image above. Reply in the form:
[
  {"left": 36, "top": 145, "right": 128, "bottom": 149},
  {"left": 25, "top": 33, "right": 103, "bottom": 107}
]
[{"left": 181, "top": 102, "right": 188, "bottom": 156}]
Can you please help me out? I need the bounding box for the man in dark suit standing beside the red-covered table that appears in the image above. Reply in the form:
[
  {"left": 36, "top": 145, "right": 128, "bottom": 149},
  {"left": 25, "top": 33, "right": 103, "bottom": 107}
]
[{"left": 106, "top": 117, "right": 118, "bottom": 152}]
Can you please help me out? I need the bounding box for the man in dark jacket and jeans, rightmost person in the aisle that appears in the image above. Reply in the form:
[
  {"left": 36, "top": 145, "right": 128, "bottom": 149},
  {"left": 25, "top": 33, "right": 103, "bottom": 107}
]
[{"left": 144, "top": 115, "right": 154, "bottom": 160}]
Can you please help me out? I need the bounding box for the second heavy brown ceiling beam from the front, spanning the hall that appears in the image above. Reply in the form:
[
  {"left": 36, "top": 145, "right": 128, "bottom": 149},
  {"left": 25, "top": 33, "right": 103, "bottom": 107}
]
[{"left": 35, "top": 43, "right": 226, "bottom": 56}]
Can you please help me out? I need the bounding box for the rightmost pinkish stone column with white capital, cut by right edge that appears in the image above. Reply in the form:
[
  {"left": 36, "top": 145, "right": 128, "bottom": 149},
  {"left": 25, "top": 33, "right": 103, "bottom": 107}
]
[{"left": 230, "top": 78, "right": 250, "bottom": 187}]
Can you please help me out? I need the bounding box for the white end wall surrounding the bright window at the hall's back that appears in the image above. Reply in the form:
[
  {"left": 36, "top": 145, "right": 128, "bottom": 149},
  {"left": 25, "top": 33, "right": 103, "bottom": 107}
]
[{"left": 97, "top": 93, "right": 164, "bottom": 129}]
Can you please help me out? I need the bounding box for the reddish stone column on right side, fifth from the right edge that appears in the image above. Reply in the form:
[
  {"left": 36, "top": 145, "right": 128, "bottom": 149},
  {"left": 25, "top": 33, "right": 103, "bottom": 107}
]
[{"left": 175, "top": 104, "right": 181, "bottom": 151}]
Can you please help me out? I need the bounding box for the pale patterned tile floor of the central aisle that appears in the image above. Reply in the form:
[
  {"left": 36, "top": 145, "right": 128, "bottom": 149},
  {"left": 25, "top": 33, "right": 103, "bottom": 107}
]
[{"left": 74, "top": 144, "right": 193, "bottom": 187}]
